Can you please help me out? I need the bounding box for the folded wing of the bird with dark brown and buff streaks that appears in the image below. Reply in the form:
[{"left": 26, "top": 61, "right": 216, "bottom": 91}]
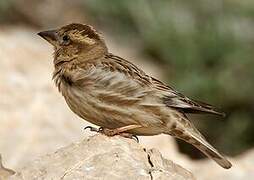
[{"left": 77, "top": 54, "right": 224, "bottom": 116}]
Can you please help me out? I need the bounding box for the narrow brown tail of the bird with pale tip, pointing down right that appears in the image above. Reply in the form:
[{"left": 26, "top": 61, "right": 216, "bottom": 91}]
[{"left": 165, "top": 125, "right": 232, "bottom": 169}]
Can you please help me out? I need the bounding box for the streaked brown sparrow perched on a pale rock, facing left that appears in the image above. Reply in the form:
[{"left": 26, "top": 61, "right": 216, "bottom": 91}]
[{"left": 38, "top": 23, "right": 232, "bottom": 169}]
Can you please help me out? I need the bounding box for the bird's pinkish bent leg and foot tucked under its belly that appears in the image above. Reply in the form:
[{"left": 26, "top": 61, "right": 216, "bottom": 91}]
[{"left": 99, "top": 124, "right": 142, "bottom": 142}]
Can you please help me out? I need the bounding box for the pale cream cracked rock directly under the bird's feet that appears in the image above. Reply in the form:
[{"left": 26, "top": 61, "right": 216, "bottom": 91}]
[{"left": 11, "top": 134, "right": 194, "bottom": 180}]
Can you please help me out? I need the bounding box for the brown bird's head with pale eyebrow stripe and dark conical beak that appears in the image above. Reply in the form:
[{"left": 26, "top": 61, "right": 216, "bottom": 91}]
[{"left": 38, "top": 23, "right": 107, "bottom": 65}]
